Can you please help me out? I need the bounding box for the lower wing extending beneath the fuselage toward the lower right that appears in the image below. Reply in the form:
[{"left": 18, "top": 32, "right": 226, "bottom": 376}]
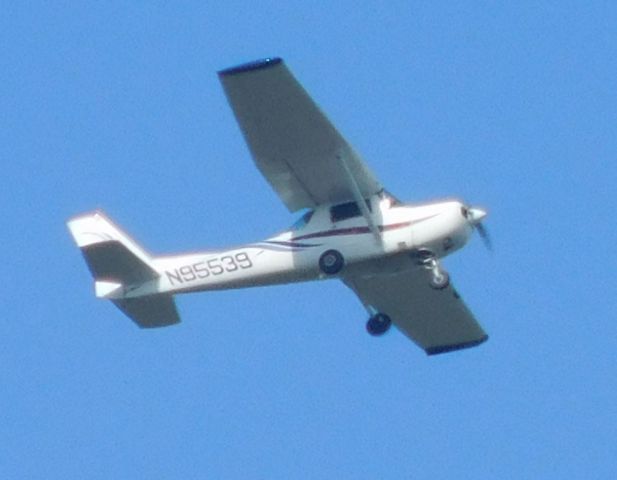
[{"left": 344, "top": 267, "right": 488, "bottom": 355}]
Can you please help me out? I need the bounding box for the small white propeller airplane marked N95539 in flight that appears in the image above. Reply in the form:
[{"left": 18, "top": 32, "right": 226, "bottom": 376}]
[{"left": 67, "top": 57, "right": 490, "bottom": 355}]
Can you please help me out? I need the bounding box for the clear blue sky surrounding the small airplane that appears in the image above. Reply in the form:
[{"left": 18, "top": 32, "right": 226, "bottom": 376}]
[{"left": 0, "top": 1, "right": 617, "bottom": 480}]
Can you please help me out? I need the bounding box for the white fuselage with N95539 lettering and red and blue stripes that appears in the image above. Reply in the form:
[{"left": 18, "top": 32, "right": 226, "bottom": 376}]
[{"left": 124, "top": 195, "right": 472, "bottom": 297}]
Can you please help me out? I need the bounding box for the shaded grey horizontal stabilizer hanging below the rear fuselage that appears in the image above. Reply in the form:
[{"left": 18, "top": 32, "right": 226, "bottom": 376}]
[{"left": 112, "top": 294, "right": 180, "bottom": 328}]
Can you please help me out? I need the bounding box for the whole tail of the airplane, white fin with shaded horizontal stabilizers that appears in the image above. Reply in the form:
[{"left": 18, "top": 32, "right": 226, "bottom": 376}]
[{"left": 68, "top": 212, "right": 180, "bottom": 328}]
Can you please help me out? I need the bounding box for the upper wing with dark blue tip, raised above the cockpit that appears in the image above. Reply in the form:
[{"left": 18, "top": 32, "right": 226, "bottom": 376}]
[{"left": 219, "top": 58, "right": 382, "bottom": 212}]
